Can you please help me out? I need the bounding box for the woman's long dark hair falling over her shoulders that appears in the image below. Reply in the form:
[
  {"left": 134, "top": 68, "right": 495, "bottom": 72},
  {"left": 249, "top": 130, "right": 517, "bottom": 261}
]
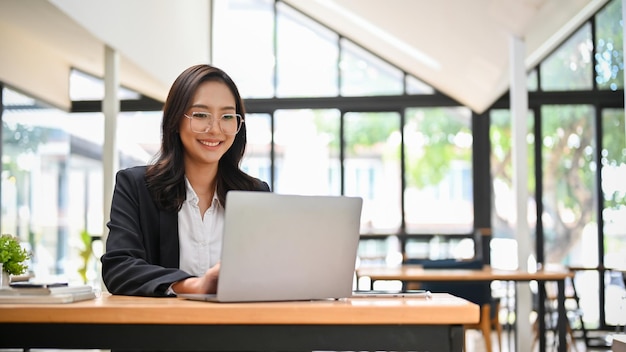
[{"left": 146, "top": 65, "right": 260, "bottom": 211}]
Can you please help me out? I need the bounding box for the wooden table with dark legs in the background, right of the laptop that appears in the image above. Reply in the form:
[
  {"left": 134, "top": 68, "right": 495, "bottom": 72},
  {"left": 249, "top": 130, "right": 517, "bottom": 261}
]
[{"left": 357, "top": 265, "right": 573, "bottom": 352}]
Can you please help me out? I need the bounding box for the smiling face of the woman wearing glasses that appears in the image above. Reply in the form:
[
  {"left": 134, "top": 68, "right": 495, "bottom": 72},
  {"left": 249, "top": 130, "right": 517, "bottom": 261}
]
[{"left": 179, "top": 81, "right": 236, "bottom": 165}]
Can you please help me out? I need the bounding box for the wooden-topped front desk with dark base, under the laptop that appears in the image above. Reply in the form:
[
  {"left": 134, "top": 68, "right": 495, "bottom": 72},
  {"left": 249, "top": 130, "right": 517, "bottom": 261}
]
[{"left": 0, "top": 294, "right": 479, "bottom": 352}]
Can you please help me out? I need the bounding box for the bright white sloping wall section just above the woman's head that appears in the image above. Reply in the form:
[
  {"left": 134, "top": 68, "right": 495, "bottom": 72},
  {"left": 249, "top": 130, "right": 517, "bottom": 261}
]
[{"left": 49, "top": 0, "right": 211, "bottom": 94}]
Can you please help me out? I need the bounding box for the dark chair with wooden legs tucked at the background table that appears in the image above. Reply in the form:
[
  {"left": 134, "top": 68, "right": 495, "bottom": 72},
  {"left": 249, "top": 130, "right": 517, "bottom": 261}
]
[{"left": 405, "top": 259, "right": 502, "bottom": 352}]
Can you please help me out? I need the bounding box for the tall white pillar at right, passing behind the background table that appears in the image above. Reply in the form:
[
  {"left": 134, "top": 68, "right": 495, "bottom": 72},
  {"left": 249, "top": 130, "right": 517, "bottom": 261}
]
[{"left": 510, "top": 34, "right": 528, "bottom": 351}]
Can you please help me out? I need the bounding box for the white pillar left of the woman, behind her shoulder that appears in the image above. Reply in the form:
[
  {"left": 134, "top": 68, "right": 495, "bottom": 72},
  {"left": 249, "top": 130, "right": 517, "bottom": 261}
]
[{"left": 102, "top": 46, "right": 120, "bottom": 289}]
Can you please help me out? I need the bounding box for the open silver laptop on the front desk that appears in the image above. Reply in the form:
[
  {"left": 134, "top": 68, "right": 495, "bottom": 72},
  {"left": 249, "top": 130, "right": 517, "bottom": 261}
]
[{"left": 178, "top": 191, "right": 363, "bottom": 302}]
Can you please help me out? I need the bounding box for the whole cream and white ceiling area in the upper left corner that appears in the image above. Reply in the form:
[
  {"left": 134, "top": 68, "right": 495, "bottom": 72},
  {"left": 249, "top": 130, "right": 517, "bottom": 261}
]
[{"left": 0, "top": 0, "right": 210, "bottom": 110}]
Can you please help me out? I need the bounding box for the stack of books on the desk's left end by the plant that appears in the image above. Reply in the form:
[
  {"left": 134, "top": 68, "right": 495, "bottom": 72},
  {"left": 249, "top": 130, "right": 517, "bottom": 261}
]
[{"left": 0, "top": 281, "right": 97, "bottom": 304}]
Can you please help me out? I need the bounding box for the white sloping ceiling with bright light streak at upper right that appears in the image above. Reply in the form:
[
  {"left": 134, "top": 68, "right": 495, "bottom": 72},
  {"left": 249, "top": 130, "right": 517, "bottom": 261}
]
[{"left": 286, "top": 0, "right": 606, "bottom": 113}]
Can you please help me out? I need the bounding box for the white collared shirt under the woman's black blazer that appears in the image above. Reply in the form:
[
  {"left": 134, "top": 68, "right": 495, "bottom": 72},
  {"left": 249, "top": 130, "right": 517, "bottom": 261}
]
[{"left": 178, "top": 177, "right": 224, "bottom": 276}]
